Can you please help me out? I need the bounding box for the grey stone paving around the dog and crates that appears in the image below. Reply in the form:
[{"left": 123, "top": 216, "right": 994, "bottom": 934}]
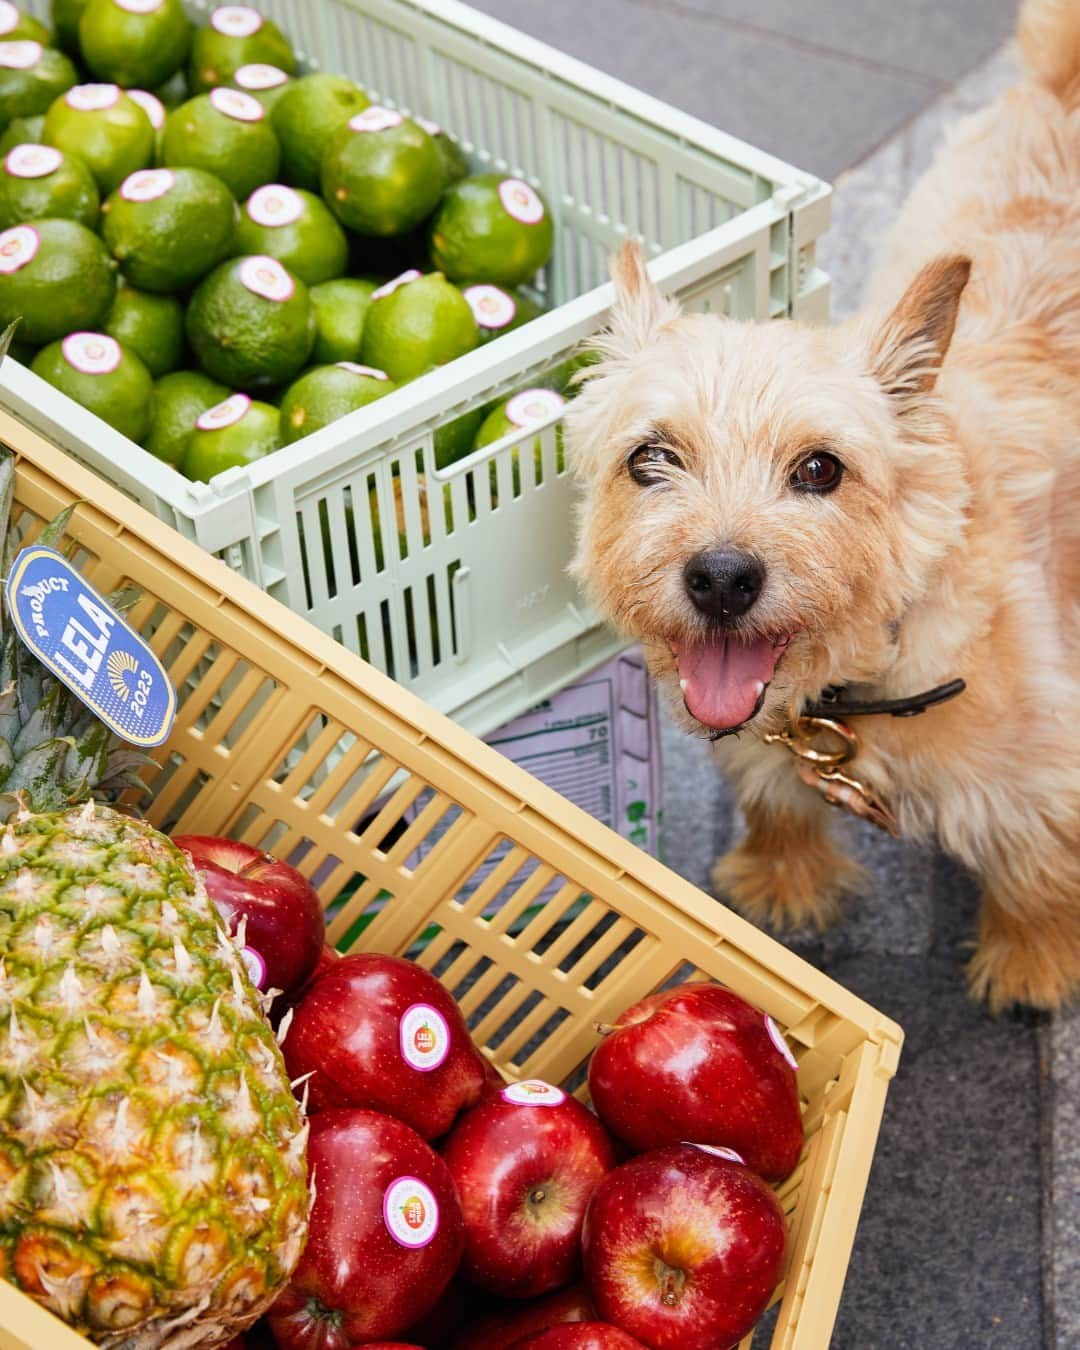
[{"left": 469, "top": 0, "right": 1080, "bottom": 1350}]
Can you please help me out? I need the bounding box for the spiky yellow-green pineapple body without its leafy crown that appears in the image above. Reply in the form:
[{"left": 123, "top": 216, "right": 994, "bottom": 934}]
[{"left": 0, "top": 806, "right": 308, "bottom": 1350}]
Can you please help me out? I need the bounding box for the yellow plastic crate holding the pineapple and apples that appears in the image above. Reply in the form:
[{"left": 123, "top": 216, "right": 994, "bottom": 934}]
[{"left": 0, "top": 413, "right": 902, "bottom": 1350}]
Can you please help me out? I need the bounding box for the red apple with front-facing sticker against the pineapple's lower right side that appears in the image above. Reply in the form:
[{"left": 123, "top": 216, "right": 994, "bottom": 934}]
[{"left": 267, "top": 1111, "right": 464, "bottom": 1350}]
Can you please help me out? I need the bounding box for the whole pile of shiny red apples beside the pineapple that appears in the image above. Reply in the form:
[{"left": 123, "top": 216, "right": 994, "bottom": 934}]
[{"left": 177, "top": 836, "right": 803, "bottom": 1350}]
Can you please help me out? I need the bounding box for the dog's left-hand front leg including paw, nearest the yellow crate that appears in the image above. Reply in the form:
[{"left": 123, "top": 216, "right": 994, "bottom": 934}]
[{"left": 713, "top": 765, "right": 863, "bottom": 930}]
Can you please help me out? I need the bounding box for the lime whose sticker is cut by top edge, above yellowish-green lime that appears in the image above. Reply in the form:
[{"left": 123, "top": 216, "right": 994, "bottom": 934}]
[{"left": 78, "top": 0, "right": 192, "bottom": 89}]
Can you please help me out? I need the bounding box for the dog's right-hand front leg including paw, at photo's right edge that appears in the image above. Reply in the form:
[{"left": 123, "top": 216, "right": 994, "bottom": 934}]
[{"left": 968, "top": 838, "right": 1080, "bottom": 1013}]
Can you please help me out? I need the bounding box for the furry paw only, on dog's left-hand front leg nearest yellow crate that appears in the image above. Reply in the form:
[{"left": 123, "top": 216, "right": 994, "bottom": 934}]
[{"left": 713, "top": 838, "right": 863, "bottom": 932}]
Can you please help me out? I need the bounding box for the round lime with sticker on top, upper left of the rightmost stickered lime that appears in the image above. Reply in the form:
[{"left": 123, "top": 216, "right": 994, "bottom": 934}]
[{"left": 323, "top": 107, "right": 446, "bottom": 235}]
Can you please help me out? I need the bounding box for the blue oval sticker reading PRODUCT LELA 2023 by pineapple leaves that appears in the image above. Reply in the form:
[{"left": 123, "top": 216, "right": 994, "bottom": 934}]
[{"left": 7, "top": 544, "right": 177, "bottom": 747}]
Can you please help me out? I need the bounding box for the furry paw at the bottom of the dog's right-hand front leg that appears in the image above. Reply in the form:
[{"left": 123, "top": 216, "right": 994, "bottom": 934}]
[{"left": 968, "top": 922, "right": 1080, "bottom": 1013}]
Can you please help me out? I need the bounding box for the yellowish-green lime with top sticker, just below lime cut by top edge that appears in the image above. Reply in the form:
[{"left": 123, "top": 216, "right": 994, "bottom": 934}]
[{"left": 42, "top": 84, "right": 154, "bottom": 197}]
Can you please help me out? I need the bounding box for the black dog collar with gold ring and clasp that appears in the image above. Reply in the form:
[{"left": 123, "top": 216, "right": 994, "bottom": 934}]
[{"left": 765, "top": 679, "right": 967, "bottom": 838}]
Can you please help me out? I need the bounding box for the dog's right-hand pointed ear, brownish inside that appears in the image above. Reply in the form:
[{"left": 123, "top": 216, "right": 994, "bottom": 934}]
[{"left": 871, "top": 254, "right": 971, "bottom": 410}]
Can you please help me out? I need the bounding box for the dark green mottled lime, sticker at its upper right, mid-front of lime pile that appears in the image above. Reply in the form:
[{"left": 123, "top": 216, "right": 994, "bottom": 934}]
[{"left": 186, "top": 255, "right": 315, "bottom": 390}]
